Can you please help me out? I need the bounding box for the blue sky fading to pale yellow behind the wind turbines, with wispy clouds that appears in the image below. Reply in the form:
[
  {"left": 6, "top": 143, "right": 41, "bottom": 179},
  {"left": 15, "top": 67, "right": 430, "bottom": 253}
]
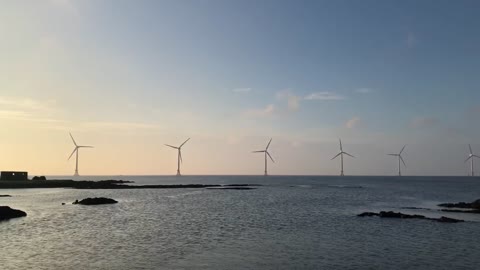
[{"left": 0, "top": 0, "right": 480, "bottom": 175}]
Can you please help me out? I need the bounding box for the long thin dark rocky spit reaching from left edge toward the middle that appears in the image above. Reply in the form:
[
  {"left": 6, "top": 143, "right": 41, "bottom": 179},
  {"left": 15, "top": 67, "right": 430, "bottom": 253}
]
[{"left": 0, "top": 180, "right": 260, "bottom": 189}]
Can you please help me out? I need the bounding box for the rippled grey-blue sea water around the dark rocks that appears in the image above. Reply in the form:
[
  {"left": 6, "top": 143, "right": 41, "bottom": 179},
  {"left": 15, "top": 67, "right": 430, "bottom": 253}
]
[{"left": 0, "top": 176, "right": 480, "bottom": 270}]
